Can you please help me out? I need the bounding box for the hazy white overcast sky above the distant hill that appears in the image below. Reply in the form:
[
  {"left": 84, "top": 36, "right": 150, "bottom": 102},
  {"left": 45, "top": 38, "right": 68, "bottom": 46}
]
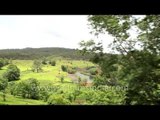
[{"left": 0, "top": 15, "right": 112, "bottom": 49}]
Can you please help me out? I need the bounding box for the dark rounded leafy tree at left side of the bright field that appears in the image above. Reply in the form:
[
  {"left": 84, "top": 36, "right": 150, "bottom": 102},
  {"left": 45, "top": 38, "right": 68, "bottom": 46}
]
[{"left": 3, "top": 64, "right": 20, "bottom": 81}]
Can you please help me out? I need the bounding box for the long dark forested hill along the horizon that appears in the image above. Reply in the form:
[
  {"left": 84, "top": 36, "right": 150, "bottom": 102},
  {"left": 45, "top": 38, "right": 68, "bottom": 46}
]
[{"left": 0, "top": 47, "right": 90, "bottom": 59}]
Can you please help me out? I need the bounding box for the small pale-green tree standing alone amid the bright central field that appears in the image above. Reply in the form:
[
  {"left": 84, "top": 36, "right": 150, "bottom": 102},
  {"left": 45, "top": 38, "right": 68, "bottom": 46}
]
[{"left": 32, "top": 60, "right": 42, "bottom": 73}]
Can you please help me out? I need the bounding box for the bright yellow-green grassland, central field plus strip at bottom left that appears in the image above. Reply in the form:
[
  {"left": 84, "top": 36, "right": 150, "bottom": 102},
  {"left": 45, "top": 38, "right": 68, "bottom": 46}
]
[{"left": 0, "top": 59, "right": 94, "bottom": 105}]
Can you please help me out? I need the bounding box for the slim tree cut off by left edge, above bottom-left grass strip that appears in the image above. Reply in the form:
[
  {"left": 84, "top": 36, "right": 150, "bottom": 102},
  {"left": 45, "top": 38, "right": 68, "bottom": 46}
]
[{"left": 0, "top": 78, "right": 8, "bottom": 101}]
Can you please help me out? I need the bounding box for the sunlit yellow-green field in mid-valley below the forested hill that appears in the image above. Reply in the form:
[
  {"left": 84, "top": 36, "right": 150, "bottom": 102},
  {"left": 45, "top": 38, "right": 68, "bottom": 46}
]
[{"left": 13, "top": 60, "right": 94, "bottom": 84}]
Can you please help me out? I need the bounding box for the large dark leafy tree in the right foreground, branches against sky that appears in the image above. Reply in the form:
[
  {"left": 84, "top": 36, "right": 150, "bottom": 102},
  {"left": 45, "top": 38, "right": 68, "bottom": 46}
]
[{"left": 80, "top": 15, "right": 160, "bottom": 104}]
